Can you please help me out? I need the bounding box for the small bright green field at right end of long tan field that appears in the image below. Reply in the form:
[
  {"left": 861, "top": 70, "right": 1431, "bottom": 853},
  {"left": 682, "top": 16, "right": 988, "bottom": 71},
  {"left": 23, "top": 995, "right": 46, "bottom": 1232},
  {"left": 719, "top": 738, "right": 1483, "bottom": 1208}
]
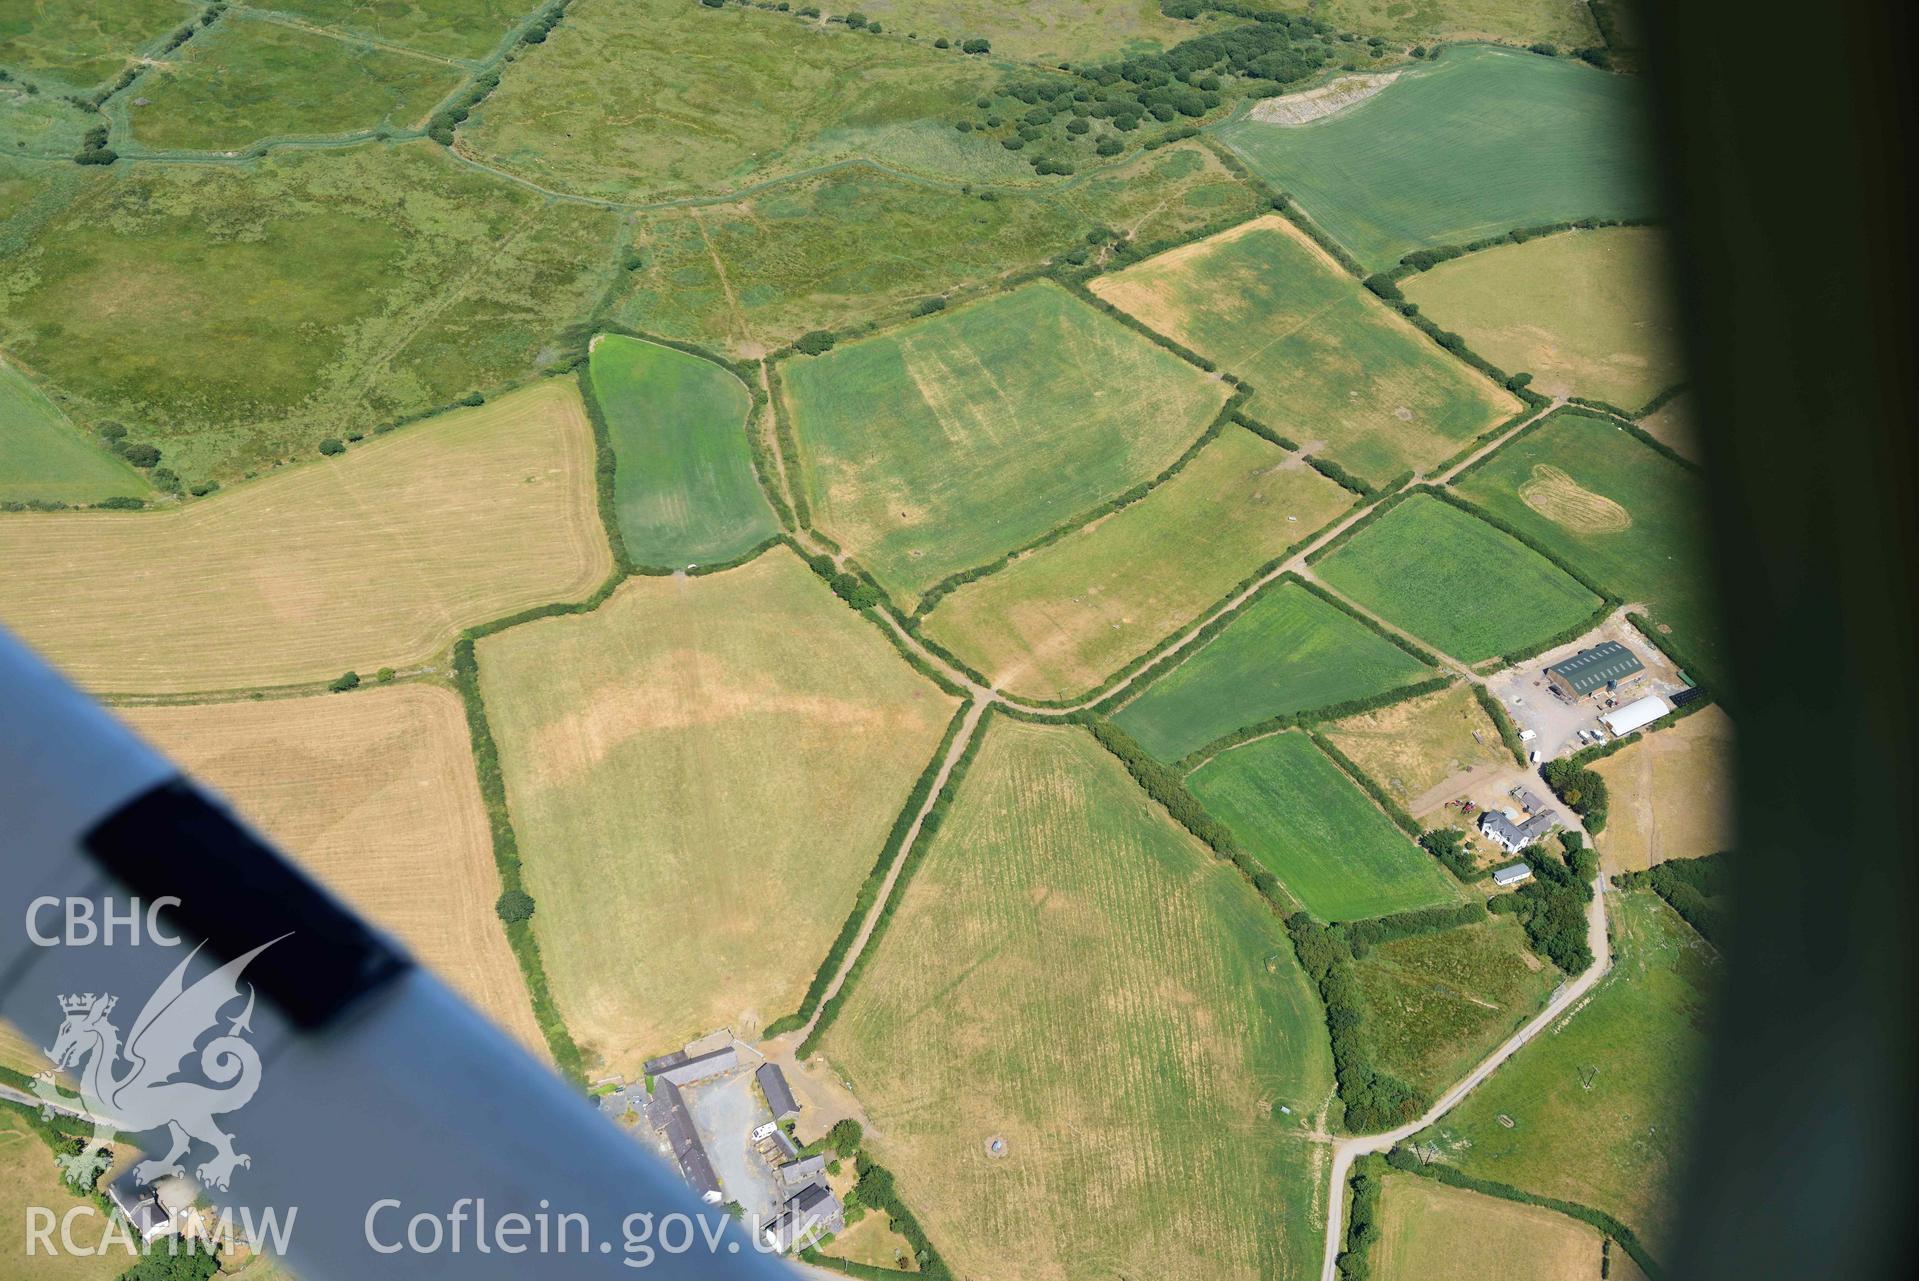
[{"left": 587, "top": 334, "right": 779, "bottom": 568}]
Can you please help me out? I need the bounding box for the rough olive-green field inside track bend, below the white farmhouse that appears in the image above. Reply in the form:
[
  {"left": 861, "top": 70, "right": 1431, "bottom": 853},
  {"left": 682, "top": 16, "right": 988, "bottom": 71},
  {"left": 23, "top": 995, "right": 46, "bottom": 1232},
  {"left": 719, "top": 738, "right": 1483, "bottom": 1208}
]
[{"left": 1353, "top": 919, "right": 1558, "bottom": 1099}]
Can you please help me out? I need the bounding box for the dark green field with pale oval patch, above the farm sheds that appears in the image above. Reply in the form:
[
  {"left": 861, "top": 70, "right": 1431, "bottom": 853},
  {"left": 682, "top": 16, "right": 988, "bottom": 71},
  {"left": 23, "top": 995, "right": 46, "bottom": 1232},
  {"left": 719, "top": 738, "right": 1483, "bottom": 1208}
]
[{"left": 1457, "top": 412, "right": 1727, "bottom": 679}]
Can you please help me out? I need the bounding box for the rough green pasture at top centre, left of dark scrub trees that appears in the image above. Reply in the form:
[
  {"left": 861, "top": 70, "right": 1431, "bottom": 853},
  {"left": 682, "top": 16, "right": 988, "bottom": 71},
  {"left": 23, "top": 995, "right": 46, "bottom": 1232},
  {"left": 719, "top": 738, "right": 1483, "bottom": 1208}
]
[{"left": 461, "top": 0, "right": 1032, "bottom": 199}]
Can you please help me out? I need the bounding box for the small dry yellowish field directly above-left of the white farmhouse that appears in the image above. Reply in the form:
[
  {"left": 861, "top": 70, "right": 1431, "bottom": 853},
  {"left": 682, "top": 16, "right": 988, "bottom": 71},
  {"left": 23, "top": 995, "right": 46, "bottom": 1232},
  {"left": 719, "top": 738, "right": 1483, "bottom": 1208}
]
[{"left": 1324, "top": 683, "right": 1512, "bottom": 817}]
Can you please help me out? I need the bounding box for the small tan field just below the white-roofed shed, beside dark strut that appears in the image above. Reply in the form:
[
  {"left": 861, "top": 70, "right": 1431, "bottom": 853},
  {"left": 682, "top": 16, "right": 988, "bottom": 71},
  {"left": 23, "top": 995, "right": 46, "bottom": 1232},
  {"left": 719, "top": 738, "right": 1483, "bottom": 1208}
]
[{"left": 1593, "top": 708, "right": 1735, "bottom": 873}]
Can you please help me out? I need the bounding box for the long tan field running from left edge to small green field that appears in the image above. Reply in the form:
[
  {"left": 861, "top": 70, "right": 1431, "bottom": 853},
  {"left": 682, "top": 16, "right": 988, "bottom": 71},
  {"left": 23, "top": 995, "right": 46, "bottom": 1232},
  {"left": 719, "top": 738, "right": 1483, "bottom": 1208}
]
[{"left": 0, "top": 380, "right": 612, "bottom": 692}]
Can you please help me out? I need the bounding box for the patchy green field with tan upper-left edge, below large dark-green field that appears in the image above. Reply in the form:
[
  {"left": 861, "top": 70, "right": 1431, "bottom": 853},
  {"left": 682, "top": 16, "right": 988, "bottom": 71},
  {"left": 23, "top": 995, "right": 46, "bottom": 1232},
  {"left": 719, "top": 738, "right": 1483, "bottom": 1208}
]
[{"left": 1092, "top": 215, "right": 1520, "bottom": 483}]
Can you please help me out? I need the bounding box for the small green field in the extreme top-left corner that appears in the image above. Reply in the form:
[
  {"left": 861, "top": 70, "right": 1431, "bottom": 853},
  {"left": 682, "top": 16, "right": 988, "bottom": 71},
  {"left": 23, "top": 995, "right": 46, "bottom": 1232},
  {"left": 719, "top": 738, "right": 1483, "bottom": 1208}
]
[{"left": 0, "top": 0, "right": 189, "bottom": 90}]
